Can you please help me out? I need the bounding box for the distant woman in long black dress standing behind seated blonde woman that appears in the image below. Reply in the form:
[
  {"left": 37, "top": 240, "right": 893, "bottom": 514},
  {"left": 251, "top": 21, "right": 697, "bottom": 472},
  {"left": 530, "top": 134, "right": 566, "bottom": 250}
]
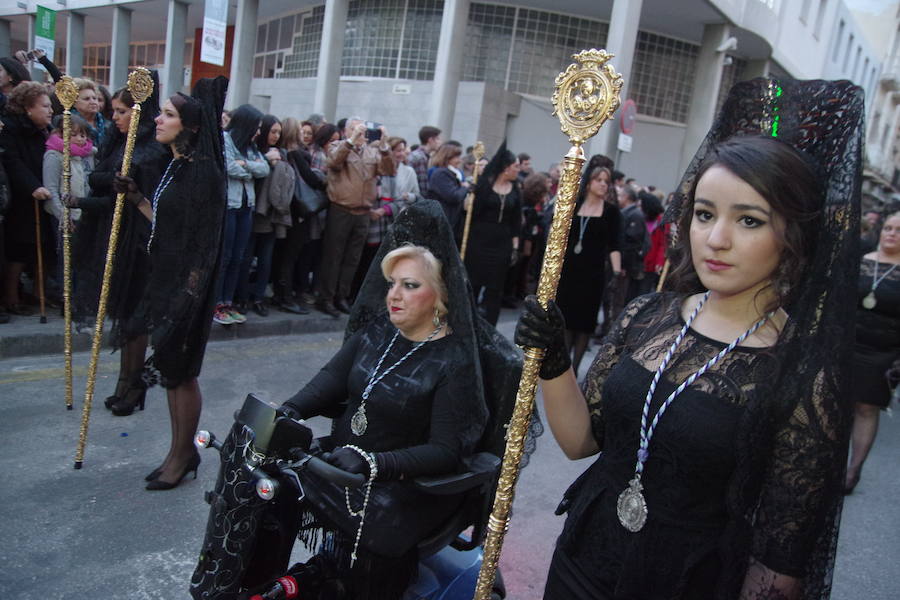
[{"left": 465, "top": 142, "right": 522, "bottom": 325}]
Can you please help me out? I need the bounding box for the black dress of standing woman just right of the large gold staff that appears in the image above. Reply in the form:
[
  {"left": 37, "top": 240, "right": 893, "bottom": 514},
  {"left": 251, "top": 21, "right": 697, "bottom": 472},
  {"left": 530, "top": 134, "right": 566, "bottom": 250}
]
[{"left": 556, "top": 202, "right": 622, "bottom": 333}]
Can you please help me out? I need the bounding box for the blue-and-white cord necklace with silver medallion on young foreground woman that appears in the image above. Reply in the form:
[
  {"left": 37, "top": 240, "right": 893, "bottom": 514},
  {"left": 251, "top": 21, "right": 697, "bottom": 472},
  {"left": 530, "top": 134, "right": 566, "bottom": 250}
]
[{"left": 616, "top": 292, "right": 775, "bottom": 532}]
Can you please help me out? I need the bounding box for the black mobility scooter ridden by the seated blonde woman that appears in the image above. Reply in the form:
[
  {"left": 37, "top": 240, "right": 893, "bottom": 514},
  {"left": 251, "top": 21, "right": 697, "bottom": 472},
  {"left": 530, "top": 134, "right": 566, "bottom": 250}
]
[{"left": 190, "top": 394, "right": 506, "bottom": 600}]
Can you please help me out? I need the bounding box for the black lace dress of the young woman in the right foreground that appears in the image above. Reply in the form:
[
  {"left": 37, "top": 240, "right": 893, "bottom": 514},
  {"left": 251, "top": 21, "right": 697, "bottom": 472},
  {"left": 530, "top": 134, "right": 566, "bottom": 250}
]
[{"left": 545, "top": 294, "right": 848, "bottom": 600}]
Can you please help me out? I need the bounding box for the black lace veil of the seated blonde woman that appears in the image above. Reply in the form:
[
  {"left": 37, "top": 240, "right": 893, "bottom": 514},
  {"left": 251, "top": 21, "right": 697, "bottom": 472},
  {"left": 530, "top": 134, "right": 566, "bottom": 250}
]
[{"left": 346, "top": 200, "right": 542, "bottom": 466}]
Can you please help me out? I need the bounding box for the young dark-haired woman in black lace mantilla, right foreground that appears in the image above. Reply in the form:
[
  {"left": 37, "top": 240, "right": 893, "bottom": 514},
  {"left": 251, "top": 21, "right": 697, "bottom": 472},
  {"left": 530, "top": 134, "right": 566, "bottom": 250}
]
[{"left": 516, "top": 79, "right": 863, "bottom": 600}]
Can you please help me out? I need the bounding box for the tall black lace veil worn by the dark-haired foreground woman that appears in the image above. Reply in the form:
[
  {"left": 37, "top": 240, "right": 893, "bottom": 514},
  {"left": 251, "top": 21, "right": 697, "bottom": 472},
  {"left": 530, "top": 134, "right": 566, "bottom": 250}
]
[{"left": 666, "top": 78, "right": 865, "bottom": 599}]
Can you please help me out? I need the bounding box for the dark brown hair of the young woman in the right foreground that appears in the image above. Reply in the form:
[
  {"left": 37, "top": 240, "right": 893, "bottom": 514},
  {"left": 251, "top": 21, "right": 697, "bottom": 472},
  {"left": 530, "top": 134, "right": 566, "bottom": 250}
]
[{"left": 668, "top": 135, "right": 822, "bottom": 311}]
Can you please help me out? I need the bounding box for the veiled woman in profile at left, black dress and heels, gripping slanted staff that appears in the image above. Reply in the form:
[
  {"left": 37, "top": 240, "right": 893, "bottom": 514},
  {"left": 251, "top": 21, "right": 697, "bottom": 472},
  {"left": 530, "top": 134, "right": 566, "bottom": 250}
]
[{"left": 115, "top": 77, "right": 227, "bottom": 490}]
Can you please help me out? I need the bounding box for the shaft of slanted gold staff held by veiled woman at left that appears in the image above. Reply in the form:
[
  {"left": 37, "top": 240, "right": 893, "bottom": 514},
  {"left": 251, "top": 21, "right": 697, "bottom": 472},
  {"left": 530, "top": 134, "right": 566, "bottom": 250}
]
[{"left": 75, "top": 102, "right": 141, "bottom": 469}]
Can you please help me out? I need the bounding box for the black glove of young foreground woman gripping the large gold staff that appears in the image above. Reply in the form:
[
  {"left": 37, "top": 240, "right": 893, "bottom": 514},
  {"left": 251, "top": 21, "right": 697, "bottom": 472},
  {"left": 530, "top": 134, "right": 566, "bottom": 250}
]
[{"left": 515, "top": 295, "right": 572, "bottom": 379}]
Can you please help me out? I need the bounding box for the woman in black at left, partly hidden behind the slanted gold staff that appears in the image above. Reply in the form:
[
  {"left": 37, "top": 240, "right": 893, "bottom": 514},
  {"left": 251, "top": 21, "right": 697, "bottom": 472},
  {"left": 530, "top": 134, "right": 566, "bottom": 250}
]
[{"left": 68, "top": 72, "right": 171, "bottom": 416}]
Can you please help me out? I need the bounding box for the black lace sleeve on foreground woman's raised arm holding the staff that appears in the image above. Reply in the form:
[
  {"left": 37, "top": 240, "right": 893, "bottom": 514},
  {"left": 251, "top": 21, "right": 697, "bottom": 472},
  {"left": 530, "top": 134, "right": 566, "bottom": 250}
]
[{"left": 582, "top": 294, "right": 663, "bottom": 449}]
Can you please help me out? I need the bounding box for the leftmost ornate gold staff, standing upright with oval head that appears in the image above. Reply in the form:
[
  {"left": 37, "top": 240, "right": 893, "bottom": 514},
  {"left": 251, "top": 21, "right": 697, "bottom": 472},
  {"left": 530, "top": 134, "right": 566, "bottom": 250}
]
[{"left": 56, "top": 75, "right": 78, "bottom": 410}]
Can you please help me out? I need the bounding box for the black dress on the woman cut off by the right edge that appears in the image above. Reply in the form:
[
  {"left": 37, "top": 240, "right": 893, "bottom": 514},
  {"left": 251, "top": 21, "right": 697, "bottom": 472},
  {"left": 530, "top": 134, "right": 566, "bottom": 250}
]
[{"left": 850, "top": 258, "right": 900, "bottom": 408}]
